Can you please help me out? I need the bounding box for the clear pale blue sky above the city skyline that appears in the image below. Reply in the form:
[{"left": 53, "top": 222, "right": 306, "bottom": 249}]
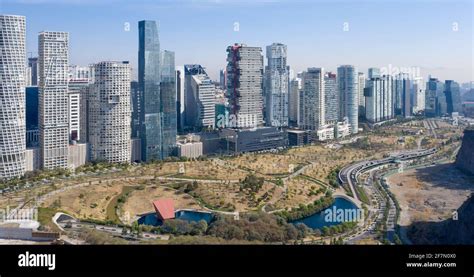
[{"left": 0, "top": 0, "right": 474, "bottom": 82}]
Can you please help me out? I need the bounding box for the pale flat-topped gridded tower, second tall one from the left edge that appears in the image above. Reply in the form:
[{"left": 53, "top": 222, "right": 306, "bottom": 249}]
[{"left": 38, "top": 32, "right": 69, "bottom": 169}]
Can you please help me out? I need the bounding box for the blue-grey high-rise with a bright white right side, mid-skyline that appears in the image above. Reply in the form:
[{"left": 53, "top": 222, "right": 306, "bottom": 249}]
[{"left": 300, "top": 68, "right": 325, "bottom": 131}]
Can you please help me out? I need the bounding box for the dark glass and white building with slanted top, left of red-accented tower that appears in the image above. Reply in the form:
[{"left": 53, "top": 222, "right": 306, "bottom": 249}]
[{"left": 184, "top": 64, "right": 216, "bottom": 129}]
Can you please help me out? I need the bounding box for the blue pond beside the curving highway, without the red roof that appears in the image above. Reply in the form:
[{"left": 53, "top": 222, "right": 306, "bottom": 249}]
[{"left": 291, "top": 197, "right": 358, "bottom": 229}]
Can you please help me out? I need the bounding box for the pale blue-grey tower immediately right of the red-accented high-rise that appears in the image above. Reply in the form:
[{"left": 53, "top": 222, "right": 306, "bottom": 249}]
[{"left": 264, "top": 43, "right": 290, "bottom": 127}]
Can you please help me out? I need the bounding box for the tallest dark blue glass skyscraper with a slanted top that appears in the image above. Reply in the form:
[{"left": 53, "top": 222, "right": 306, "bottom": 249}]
[{"left": 138, "top": 20, "right": 162, "bottom": 161}]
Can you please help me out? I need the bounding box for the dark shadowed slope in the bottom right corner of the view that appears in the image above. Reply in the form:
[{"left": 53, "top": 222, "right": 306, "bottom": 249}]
[{"left": 407, "top": 194, "right": 474, "bottom": 245}]
